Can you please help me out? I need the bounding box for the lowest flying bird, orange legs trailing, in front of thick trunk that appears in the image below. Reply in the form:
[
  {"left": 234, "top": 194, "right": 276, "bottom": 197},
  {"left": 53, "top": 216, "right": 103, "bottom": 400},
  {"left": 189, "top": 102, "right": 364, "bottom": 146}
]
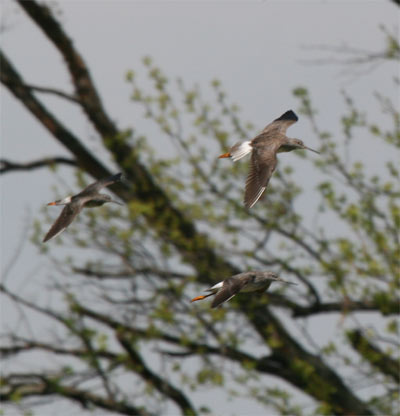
[{"left": 191, "top": 271, "right": 296, "bottom": 308}]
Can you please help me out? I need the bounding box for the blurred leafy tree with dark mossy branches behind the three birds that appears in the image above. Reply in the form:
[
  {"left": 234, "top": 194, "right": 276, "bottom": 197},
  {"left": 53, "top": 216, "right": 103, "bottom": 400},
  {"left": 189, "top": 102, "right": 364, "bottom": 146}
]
[{"left": 0, "top": 1, "right": 400, "bottom": 415}]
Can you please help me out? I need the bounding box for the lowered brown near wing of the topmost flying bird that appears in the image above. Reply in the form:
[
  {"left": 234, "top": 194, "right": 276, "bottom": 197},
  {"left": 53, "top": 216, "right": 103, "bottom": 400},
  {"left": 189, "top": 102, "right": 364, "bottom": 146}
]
[{"left": 244, "top": 146, "right": 277, "bottom": 208}]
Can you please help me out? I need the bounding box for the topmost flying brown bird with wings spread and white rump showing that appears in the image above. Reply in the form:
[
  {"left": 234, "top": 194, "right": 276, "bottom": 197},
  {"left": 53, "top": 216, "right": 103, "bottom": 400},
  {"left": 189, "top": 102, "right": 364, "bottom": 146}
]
[{"left": 219, "top": 110, "right": 319, "bottom": 208}]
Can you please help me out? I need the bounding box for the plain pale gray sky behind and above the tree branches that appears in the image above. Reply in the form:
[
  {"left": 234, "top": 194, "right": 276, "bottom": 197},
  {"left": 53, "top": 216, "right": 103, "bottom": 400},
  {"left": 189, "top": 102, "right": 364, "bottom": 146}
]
[{"left": 1, "top": 0, "right": 399, "bottom": 413}]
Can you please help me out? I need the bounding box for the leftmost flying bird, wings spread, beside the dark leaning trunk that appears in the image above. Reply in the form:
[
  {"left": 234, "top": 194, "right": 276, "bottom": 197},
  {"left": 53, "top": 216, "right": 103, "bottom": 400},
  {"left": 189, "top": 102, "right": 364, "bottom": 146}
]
[{"left": 43, "top": 173, "right": 122, "bottom": 243}]
